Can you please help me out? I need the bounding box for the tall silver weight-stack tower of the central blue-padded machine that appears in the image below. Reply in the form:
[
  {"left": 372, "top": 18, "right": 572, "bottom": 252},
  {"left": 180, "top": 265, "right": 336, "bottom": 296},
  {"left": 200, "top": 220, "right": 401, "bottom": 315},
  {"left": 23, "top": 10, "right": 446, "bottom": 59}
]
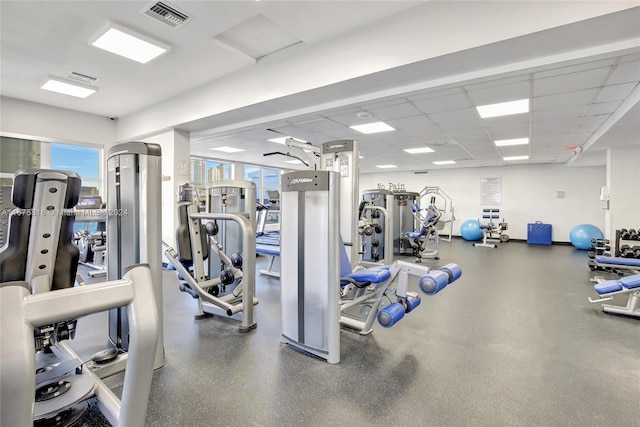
[{"left": 280, "top": 171, "right": 340, "bottom": 363}]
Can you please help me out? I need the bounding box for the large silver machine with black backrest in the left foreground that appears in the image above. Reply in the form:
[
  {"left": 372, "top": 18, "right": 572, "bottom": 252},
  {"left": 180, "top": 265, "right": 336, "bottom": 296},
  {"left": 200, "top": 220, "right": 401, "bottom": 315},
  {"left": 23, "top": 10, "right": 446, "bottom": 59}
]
[{"left": 0, "top": 169, "right": 161, "bottom": 426}]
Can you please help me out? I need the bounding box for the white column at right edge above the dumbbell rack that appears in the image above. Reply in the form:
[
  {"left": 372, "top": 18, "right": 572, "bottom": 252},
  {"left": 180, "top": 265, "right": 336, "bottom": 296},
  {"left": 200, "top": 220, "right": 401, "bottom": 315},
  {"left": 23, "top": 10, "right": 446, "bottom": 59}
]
[{"left": 605, "top": 145, "right": 640, "bottom": 239}]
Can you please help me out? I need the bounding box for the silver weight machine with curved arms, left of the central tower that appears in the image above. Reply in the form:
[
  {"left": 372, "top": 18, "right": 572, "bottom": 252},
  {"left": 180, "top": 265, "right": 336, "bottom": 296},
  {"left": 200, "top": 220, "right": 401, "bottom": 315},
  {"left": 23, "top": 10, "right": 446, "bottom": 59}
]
[{"left": 162, "top": 181, "right": 258, "bottom": 332}]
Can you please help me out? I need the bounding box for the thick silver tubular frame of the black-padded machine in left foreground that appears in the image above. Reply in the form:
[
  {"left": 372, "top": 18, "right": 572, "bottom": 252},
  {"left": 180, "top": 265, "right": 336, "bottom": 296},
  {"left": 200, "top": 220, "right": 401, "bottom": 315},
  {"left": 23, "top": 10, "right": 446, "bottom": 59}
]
[{"left": 0, "top": 170, "right": 162, "bottom": 426}]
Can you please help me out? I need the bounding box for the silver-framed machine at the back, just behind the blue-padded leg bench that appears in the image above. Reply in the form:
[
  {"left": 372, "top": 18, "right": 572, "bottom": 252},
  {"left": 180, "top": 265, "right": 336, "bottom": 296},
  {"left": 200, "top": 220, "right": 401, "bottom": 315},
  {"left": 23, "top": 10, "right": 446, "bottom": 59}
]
[{"left": 358, "top": 189, "right": 393, "bottom": 267}]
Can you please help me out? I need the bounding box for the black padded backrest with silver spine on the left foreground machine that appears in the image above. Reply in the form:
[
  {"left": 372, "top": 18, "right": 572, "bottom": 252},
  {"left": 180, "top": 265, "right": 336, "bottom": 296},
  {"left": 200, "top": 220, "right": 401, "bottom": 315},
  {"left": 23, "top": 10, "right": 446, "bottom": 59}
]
[{"left": 0, "top": 169, "right": 82, "bottom": 293}]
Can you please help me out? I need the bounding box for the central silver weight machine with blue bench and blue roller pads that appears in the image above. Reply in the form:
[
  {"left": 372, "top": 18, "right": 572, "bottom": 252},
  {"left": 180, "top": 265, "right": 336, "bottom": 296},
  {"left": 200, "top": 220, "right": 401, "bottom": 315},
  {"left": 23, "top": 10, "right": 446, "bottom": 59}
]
[{"left": 280, "top": 171, "right": 462, "bottom": 363}]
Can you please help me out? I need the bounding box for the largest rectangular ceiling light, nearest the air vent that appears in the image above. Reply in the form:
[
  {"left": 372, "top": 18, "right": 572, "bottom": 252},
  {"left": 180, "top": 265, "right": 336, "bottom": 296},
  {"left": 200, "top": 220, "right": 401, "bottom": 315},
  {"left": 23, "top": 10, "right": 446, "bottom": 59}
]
[{"left": 91, "top": 24, "right": 169, "bottom": 64}]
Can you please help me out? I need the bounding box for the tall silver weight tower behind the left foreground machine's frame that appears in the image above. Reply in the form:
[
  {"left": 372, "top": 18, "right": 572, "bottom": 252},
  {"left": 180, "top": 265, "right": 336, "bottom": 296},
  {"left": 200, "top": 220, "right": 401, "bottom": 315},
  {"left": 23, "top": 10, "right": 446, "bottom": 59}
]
[{"left": 104, "top": 142, "right": 164, "bottom": 372}]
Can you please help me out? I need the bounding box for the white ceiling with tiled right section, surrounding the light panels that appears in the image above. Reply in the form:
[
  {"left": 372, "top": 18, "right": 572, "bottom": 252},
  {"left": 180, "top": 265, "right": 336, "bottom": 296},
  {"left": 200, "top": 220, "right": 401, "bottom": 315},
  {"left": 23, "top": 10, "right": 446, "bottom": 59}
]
[{"left": 0, "top": 0, "right": 640, "bottom": 173}]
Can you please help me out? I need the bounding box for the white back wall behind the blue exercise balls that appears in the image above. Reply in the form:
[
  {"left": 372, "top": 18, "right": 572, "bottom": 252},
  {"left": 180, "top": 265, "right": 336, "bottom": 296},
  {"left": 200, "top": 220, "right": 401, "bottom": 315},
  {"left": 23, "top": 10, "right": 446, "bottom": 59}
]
[{"left": 360, "top": 165, "right": 606, "bottom": 242}]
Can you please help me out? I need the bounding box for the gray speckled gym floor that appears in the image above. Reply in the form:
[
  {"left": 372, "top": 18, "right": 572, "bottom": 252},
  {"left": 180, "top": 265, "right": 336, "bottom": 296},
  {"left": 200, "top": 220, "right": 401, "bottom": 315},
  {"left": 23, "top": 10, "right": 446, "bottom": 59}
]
[{"left": 66, "top": 240, "right": 640, "bottom": 426}]
